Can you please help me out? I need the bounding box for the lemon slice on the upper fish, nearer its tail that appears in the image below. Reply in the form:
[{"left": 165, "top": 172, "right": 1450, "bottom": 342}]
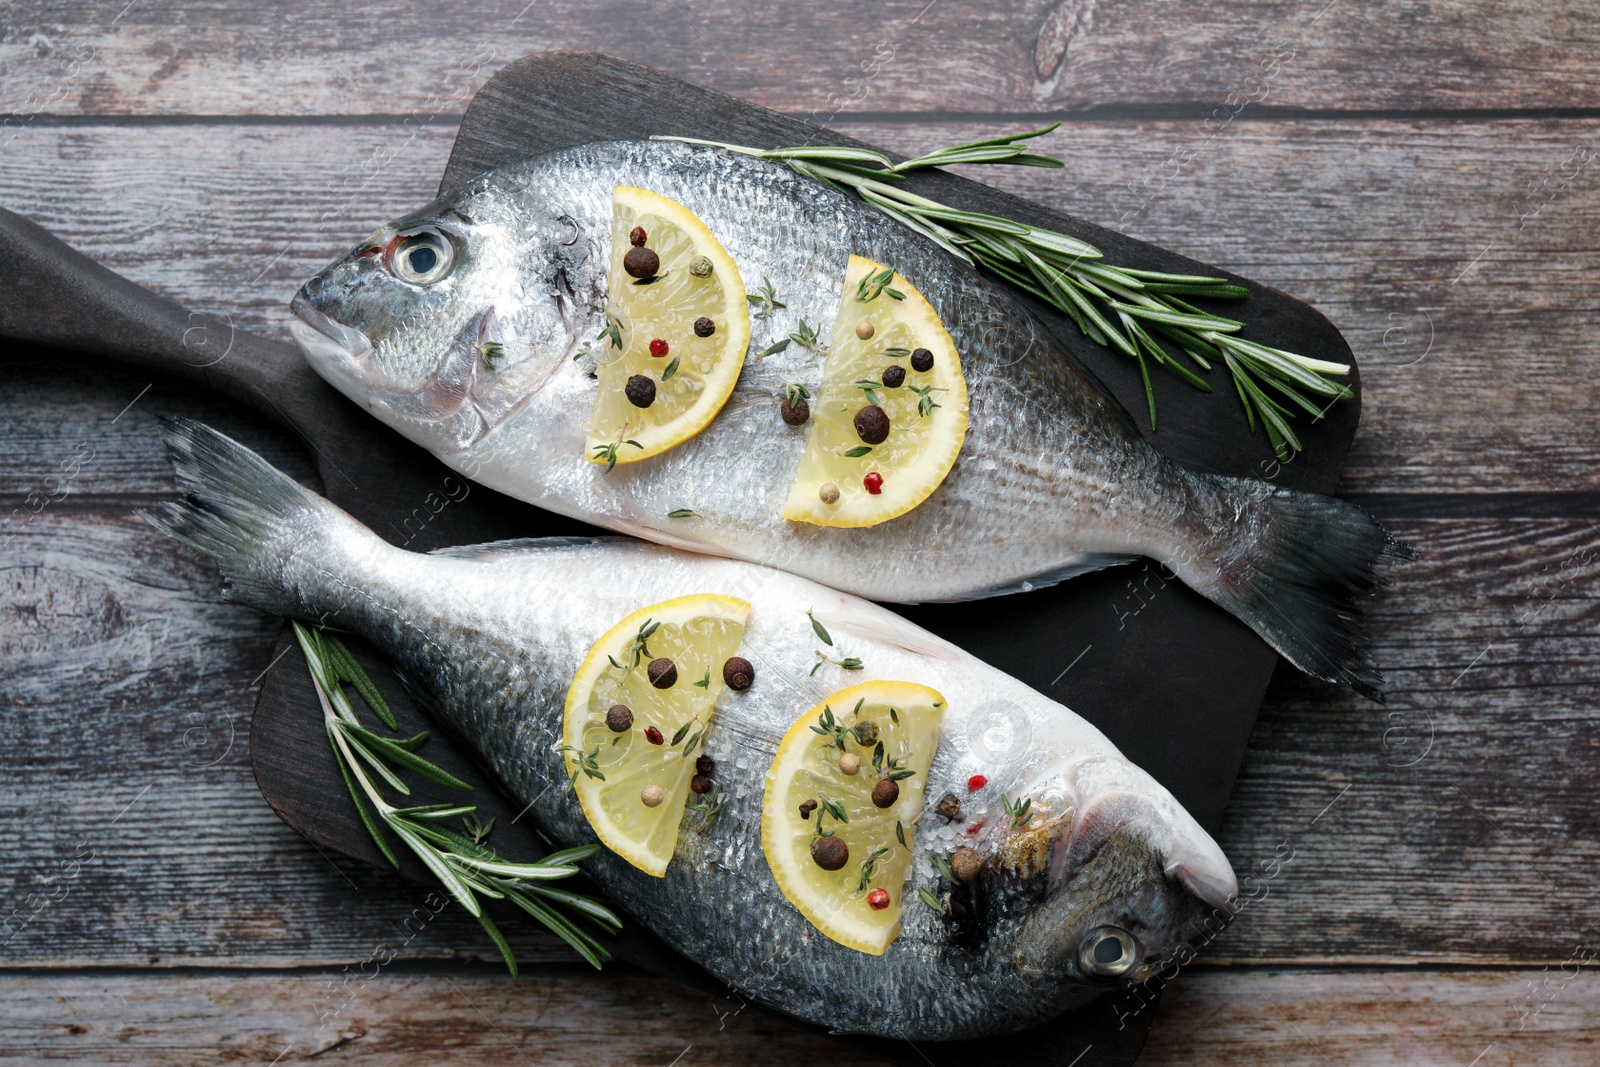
[{"left": 782, "top": 256, "right": 966, "bottom": 526}]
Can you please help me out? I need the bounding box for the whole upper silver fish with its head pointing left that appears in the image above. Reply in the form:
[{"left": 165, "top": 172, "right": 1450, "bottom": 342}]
[{"left": 293, "top": 141, "right": 1405, "bottom": 699}]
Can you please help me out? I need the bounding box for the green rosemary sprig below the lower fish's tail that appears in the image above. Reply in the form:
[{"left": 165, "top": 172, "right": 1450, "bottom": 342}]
[{"left": 294, "top": 622, "right": 622, "bottom": 977}]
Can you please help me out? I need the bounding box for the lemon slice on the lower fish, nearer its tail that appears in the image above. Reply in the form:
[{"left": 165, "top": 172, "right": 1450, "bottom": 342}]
[{"left": 562, "top": 593, "right": 750, "bottom": 878}]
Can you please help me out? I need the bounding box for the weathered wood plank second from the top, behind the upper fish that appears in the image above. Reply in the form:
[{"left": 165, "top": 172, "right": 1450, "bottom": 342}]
[{"left": 0, "top": 120, "right": 1600, "bottom": 502}]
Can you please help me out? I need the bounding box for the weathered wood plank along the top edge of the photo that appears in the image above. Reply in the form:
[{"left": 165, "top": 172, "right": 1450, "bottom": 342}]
[{"left": 0, "top": 0, "right": 1600, "bottom": 117}]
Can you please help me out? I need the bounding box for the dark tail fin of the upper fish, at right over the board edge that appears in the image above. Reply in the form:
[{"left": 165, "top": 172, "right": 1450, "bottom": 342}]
[{"left": 1184, "top": 477, "right": 1414, "bottom": 702}]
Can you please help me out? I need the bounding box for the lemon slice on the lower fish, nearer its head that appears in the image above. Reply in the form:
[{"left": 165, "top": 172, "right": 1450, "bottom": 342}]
[{"left": 762, "top": 681, "right": 944, "bottom": 955}]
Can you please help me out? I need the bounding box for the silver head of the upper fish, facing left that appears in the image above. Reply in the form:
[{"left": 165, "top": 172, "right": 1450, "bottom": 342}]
[{"left": 290, "top": 179, "right": 578, "bottom": 458}]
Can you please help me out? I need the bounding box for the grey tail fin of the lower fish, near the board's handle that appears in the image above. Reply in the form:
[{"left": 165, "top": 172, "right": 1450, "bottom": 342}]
[{"left": 138, "top": 418, "right": 373, "bottom": 619}]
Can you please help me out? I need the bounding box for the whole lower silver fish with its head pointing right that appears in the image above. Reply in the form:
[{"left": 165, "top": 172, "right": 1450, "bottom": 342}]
[{"left": 146, "top": 421, "right": 1237, "bottom": 1040}]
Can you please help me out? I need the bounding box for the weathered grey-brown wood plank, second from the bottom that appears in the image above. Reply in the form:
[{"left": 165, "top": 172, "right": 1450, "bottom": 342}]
[{"left": 0, "top": 492, "right": 1600, "bottom": 966}]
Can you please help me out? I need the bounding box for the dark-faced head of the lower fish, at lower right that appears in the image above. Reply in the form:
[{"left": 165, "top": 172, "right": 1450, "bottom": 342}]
[{"left": 1011, "top": 765, "right": 1238, "bottom": 1003}]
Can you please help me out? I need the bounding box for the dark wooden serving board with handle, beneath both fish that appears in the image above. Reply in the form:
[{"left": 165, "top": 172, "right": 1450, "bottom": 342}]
[{"left": 0, "top": 53, "right": 1360, "bottom": 1067}]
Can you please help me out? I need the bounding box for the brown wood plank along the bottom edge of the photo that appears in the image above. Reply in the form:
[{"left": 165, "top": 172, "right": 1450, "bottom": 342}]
[{"left": 0, "top": 966, "right": 1600, "bottom": 1067}]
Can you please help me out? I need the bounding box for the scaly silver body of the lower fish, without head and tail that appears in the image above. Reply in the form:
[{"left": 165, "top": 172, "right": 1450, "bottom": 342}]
[{"left": 283, "top": 528, "right": 1190, "bottom": 1038}]
